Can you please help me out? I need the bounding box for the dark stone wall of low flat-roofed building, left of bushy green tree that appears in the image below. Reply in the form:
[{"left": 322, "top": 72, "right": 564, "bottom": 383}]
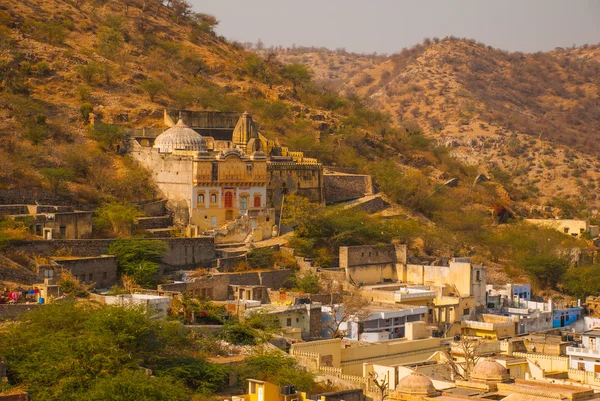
[{"left": 54, "top": 255, "right": 117, "bottom": 288}]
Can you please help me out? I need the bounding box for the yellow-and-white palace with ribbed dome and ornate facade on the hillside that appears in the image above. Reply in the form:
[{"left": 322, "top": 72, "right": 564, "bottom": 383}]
[{"left": 132, "top": 110, "right": 323, "bottom": 239}]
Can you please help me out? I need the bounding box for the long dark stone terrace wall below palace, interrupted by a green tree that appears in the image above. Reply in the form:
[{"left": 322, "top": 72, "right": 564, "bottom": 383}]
[{"left": 10, "top": 237, "right": 215, "bottom": 270}]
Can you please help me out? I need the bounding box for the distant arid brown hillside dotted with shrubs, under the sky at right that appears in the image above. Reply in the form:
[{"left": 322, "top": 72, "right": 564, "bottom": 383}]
[{"left": 262, "top": 38, "right": 600, "bottom": 211}]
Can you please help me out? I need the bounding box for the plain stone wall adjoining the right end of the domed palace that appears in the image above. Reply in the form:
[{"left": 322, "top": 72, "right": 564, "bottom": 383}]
[{"left": 323, "top": 174, "right": 373, "bottom": 204}]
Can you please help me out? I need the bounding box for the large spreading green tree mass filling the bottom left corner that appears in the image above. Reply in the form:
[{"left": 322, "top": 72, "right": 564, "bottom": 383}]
[{"left": 0, "top": 302, "right": 206, "bottom": 401}]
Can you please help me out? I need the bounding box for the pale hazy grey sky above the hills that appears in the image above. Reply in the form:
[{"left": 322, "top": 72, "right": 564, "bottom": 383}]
[{"left": 190, "top": 0, "right": 600, "bottom": 53}]
